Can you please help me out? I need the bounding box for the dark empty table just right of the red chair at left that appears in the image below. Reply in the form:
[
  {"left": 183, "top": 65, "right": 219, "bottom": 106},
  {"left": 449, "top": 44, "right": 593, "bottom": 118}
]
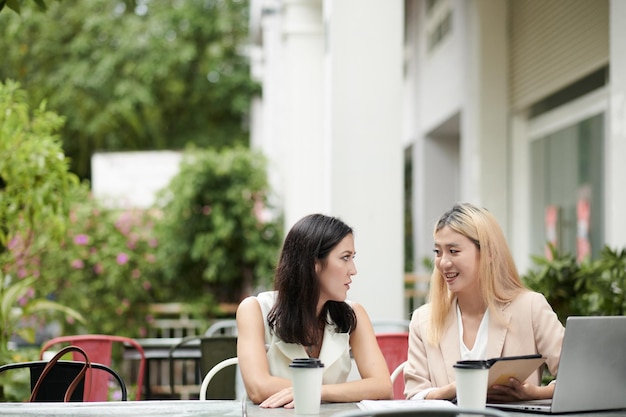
[{"left": 123, "top": 337, "right": 202, "bottom": 400}]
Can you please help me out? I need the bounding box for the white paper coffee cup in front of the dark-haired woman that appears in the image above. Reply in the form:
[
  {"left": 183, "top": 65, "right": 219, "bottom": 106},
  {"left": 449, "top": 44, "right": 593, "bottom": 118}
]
[{"left": 289, "top": 358, "right": 324, "bottom": 414}]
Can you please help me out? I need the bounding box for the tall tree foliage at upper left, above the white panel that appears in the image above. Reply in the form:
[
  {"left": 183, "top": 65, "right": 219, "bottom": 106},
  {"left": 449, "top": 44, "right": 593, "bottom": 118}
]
[{"left": 0, "top": 0, "right": 258, "bottom": 178}]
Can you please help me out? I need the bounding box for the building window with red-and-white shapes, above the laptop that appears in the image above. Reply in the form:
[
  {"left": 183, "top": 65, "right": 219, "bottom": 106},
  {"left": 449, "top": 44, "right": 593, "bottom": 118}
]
[{"left": 531, "top": 114, "right": 604, "bottom": 260}]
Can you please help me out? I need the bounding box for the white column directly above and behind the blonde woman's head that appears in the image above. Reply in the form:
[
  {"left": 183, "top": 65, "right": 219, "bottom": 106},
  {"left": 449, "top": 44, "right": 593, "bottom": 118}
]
[{"left": 461, "top": 0, "right": 510, "bottom": 228}]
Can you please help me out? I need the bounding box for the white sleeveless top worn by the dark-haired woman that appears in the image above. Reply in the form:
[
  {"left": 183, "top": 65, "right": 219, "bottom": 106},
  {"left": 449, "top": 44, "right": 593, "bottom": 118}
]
[{"left": 256, "top": 291, "right": 352, "bottom": 384}]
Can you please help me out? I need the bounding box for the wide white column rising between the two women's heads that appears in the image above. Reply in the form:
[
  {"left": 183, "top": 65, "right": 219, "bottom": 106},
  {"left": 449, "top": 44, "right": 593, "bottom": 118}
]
[{"left": 324, "top": 0, "right": 406, "bottom": 319}]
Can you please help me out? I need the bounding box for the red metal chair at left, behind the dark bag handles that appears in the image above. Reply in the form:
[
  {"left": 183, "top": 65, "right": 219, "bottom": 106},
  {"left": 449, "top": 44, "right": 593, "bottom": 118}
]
[{"left": 39, "top": 334, "right": 146, "bottom": 401}]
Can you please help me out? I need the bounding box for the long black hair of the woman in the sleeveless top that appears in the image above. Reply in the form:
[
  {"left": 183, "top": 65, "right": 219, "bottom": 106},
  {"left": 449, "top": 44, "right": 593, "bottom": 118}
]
[{"left": 267, "top": 214, "right": 356, "bottom": 346}]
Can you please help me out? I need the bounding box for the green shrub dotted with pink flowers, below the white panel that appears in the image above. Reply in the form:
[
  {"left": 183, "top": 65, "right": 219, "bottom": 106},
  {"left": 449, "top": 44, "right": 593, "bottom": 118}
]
[{"left": 40, "top": 194, "right": 158, "bottom": 337}]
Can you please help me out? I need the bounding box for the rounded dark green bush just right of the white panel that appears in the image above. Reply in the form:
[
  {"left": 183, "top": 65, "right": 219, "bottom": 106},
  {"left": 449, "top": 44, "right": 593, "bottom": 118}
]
[{"left": 156, "top": 147, "right": 282, "bottom": 302}]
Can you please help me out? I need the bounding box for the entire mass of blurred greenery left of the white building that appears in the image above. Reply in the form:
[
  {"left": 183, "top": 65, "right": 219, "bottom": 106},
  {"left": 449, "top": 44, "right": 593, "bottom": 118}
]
[{"left": 0, "top": 0, "right": 282, "bottom": 363}]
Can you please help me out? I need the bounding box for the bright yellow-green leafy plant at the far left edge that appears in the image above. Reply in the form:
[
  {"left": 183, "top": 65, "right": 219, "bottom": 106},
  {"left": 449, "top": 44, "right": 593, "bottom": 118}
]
[{"left": 0, "top": 82, "right": 82, "bottom": 362}]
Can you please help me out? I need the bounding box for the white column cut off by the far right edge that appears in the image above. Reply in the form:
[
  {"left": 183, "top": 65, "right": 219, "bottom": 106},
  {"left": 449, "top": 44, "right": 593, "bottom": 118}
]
[{"left": 604, "top": 0, "right": 626, "bottom": 245}]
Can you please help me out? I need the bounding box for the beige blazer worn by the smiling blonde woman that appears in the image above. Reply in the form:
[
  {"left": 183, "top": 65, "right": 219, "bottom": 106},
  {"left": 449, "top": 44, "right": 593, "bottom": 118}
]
[{"left": 404, "top": 291, "right": 565, "bottom": 398}]
